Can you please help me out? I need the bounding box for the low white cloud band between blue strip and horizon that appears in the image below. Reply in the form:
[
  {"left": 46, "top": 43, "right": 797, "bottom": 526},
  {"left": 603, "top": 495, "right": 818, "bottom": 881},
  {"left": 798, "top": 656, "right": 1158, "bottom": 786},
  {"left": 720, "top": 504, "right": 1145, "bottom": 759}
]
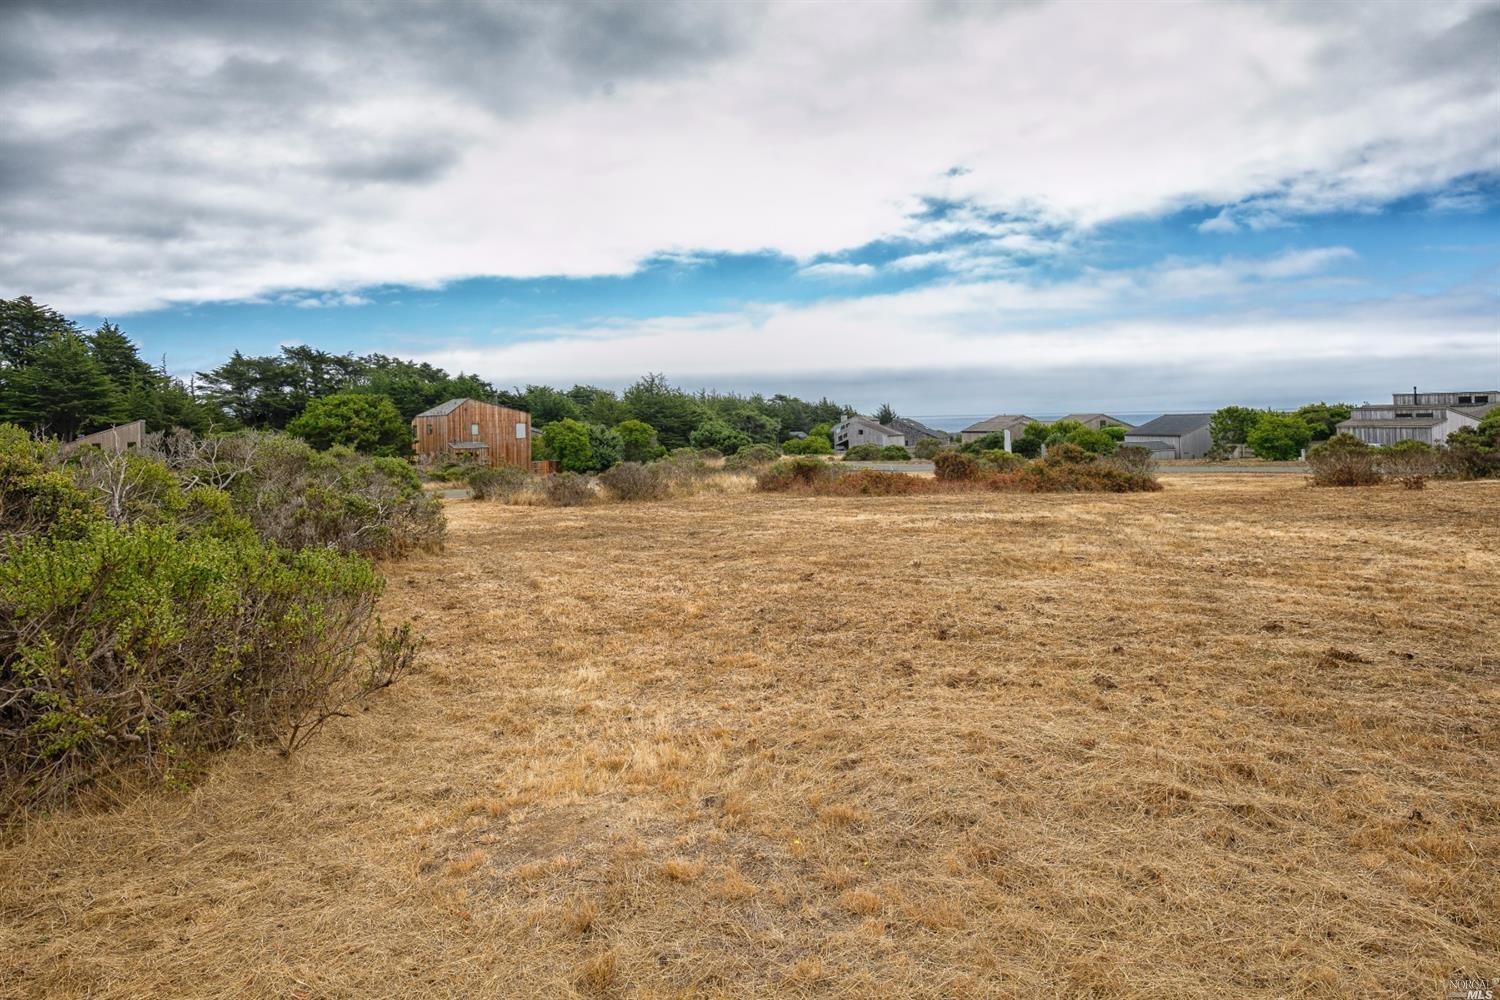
[{"left": 405, "top": 247, "right": 1500, "bottom": 408}]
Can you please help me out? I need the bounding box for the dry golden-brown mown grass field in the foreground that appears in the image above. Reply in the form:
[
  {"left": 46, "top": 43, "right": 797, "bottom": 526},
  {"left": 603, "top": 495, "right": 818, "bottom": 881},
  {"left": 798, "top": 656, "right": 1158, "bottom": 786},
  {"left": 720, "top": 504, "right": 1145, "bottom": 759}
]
[{"left": 0, "top": 475, "right": 1500, "bottom": 997}]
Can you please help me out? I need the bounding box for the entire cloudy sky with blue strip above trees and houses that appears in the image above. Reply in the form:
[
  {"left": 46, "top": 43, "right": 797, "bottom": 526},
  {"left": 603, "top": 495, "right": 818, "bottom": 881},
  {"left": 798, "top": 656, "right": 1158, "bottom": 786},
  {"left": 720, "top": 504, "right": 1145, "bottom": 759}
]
[{"left": 0, "top": 0, "right": 1500, "bottom": 418}]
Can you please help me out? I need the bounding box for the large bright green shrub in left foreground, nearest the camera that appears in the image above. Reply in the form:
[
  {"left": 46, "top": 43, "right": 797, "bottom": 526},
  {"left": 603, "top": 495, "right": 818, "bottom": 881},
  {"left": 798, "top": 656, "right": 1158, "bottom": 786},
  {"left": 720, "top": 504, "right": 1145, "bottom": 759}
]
[{"left": 0, "top": 523, "right": 381, "bottom": 808}]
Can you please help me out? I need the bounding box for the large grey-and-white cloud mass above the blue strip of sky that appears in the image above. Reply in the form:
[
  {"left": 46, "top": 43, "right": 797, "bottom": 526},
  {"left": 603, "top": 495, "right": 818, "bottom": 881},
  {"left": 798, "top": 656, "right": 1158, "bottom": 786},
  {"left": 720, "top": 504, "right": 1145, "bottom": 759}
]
[{"left": 0, "top": 1, "right": 1500, "bottom": 313}]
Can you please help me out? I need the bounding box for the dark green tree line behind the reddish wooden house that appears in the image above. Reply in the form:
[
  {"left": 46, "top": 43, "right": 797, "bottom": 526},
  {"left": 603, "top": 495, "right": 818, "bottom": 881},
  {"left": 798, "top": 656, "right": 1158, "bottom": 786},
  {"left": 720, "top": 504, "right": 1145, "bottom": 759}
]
[{"left": 0, "top": 295, "right": 854, "bottom": 454}]
